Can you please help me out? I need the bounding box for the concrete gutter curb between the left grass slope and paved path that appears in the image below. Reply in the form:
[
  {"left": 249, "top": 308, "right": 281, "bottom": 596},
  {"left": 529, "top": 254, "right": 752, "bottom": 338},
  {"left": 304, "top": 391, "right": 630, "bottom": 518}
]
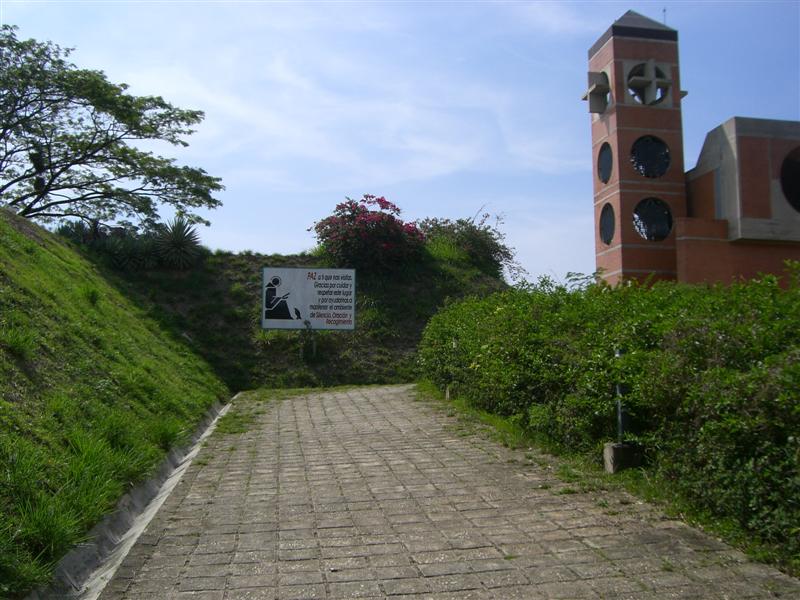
[{"left": 25, "top": 392, "right": 241, "bottom": 600}]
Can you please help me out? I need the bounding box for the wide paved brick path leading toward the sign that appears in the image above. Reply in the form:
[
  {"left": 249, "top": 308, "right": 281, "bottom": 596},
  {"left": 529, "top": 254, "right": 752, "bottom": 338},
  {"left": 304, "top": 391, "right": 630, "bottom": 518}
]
[{"left": 101, "top": 386, "right": 800, "bottom": 600}]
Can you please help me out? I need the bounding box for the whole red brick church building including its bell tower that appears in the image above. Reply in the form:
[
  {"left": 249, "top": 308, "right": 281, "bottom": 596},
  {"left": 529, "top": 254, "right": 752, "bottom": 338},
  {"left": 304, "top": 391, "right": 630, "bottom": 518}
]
[{"left": 584, "top": 11, "right": 800, "bottom": 284}]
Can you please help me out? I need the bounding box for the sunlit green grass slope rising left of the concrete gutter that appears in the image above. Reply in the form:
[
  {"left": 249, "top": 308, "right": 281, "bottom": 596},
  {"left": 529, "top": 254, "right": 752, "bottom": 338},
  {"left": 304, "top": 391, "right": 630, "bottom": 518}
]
[{"left": 0, "top": 210, "right": 229, "bottom": 597}]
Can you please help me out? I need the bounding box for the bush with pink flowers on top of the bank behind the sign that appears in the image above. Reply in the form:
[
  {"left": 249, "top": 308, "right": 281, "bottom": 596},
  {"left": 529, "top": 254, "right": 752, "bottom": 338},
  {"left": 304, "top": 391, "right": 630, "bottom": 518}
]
[{"left": 313, "top": 194, "right": 425, "bottom": 270}]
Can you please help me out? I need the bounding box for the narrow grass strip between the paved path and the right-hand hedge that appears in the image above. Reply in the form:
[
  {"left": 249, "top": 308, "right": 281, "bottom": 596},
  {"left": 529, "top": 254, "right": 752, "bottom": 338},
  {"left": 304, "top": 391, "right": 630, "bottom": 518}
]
[{"left": 417, "top": 381, "right": 800, "bottom": 577}]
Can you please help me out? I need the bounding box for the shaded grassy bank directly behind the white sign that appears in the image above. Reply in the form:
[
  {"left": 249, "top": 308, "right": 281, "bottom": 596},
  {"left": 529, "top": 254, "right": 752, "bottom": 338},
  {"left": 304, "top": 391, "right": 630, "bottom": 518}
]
[{"left": 104, "top": 244, "right": 506, "bottom": 391}]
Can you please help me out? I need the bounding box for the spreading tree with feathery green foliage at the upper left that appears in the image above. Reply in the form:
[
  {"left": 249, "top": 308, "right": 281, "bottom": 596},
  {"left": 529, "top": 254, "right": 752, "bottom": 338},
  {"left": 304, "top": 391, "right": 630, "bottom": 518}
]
[{"left": 0, "top": 25, "right": 224, "bottom": 228}]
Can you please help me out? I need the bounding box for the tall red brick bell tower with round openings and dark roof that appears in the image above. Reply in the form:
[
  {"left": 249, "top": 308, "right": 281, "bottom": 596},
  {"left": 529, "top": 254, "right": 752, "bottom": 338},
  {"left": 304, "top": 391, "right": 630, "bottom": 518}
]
[{"left": 583, "top": 11, "right": 686, "bottom": 285}]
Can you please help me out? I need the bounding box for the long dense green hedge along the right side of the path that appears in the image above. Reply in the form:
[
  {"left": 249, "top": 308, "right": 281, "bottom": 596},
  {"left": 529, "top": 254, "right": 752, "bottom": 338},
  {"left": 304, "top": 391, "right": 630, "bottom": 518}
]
[{"left": 419, "top": 264, "right": 800, "bottom": 560}]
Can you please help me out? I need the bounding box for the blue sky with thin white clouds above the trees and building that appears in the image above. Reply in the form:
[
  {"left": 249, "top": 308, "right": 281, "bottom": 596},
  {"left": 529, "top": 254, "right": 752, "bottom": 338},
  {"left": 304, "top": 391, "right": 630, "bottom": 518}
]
[{"left": 0, "top": 0, "right": 800, "bottom": 278}]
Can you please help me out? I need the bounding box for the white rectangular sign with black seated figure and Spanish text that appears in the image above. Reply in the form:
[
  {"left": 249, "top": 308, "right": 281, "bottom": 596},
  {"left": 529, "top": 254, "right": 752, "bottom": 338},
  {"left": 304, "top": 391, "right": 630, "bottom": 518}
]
[{"left": 261, "top": 267, "right": 356, "bottom": 329}]
